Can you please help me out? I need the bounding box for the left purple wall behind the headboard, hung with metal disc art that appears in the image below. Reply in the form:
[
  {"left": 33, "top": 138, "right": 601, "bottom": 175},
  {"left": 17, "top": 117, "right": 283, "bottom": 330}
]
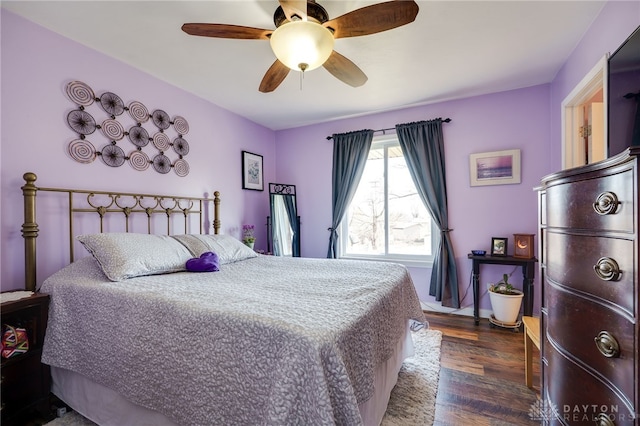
[{"left": 0, "top": 9, "right": 275, "bottom": 291}]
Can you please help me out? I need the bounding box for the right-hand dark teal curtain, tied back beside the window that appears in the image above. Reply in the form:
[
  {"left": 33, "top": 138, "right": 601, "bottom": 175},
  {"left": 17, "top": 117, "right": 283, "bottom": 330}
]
[{"left": 396, "top": 118, "right": 460, "bottom": 308}]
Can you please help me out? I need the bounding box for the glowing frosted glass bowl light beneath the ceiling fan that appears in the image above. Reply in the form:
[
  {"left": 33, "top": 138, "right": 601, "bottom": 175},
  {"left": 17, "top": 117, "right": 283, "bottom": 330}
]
[{"left": 270, "top": 21, "right": 334, "bottom": 71}]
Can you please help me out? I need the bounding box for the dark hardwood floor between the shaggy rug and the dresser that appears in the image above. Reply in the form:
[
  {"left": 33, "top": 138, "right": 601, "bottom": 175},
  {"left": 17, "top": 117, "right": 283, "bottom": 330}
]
[{"left": 426, "top": 312, "right": 540, "bottom": 426}]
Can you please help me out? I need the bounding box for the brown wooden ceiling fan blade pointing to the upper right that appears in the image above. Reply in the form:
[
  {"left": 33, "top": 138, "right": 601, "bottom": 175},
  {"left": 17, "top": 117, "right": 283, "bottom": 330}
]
[{"left": 322, "top": 1, "right": 418, "bottom": 38}]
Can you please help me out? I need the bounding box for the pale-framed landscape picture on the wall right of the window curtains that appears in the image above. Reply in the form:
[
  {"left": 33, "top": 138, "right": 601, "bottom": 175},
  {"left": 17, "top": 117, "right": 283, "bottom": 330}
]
[{"left": 469, "top": 149, "right": 520, "bottom": 186}]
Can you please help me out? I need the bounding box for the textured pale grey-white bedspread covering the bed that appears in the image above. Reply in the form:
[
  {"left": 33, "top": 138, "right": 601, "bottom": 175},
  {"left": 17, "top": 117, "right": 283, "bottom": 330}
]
[{"left": 41, "top": 256, "right": 424, "bottom": 425}]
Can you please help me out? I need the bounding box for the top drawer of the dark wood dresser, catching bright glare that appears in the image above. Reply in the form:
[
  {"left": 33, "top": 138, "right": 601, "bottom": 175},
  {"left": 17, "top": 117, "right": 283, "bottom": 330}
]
[{"left": 546, "top": 169, "right": 634, "bottom": 232}]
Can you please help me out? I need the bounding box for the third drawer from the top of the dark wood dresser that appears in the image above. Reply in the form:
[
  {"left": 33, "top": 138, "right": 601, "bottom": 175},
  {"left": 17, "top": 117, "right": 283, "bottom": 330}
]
[{"left": 545, "top": 285, "right": 635, "bottom": 401}]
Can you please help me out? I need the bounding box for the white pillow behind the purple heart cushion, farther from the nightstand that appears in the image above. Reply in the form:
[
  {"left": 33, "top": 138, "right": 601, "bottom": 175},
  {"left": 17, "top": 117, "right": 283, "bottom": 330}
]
[{"left": 173, "top": 234, "right": 258, "bottom": 265}]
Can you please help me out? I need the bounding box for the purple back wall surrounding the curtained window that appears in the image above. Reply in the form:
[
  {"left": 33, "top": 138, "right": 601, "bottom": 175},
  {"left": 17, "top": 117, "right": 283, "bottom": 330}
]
[{"left": 276, "top": 85, "right": 549, "bottom": 308}]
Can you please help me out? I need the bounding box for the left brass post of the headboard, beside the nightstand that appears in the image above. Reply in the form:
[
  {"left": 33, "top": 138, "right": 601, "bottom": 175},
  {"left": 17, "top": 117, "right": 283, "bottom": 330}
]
[{"left": 22, "top": 173, "right": 38, "bottom": 291}]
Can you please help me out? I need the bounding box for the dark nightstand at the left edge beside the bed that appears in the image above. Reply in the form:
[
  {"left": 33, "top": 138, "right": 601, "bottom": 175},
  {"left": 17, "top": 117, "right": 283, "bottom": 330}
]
[{"left": 0, "top": 293, "right": 53, "bottom": 426}]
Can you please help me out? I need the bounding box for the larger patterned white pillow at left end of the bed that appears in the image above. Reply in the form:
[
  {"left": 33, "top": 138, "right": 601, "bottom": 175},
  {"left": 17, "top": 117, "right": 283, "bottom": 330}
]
[{"left": 76, "top": 233, "right": 193, "bottom": 281}]
